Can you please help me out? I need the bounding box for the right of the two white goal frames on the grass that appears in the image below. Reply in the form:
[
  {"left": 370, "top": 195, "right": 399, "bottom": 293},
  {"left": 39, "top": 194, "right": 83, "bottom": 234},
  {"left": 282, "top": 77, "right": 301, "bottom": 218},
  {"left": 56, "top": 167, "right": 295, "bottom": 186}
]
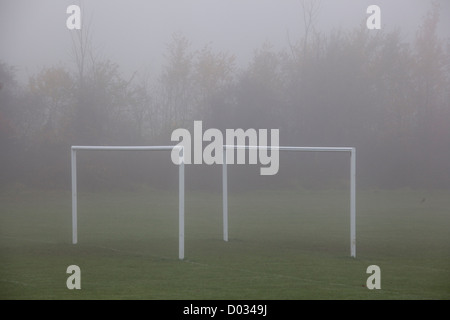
[{"left": 222, "top": 145, "right": 356, "bottom": 258}]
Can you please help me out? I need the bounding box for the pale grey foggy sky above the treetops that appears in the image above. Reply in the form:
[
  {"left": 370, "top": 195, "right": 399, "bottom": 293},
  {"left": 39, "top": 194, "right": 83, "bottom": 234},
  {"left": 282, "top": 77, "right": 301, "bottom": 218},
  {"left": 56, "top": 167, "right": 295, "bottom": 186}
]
[{"left": 0, "top": 0, "right": 450, "bottom": 80}]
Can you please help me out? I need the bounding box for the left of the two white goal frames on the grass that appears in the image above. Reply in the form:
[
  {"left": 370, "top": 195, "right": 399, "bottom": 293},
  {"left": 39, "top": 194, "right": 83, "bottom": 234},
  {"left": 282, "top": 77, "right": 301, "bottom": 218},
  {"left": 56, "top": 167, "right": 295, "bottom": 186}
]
[{"left": 71, "top": 145, "right": 184, "bottom": 260}]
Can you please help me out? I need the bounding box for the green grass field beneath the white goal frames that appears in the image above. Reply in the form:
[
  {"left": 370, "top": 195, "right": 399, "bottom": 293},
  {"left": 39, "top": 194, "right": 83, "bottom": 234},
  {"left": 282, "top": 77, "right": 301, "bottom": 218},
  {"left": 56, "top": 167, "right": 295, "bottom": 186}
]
[{"left": 0, "top": 186, "right": 450, "bottom": 300}]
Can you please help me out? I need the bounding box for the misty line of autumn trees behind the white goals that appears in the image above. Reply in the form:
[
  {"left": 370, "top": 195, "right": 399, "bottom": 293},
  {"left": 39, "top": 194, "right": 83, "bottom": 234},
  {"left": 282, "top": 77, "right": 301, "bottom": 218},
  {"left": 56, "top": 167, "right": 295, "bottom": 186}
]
[{"left": 0, "top": 8, "right": 450, "bottom": 188}]
